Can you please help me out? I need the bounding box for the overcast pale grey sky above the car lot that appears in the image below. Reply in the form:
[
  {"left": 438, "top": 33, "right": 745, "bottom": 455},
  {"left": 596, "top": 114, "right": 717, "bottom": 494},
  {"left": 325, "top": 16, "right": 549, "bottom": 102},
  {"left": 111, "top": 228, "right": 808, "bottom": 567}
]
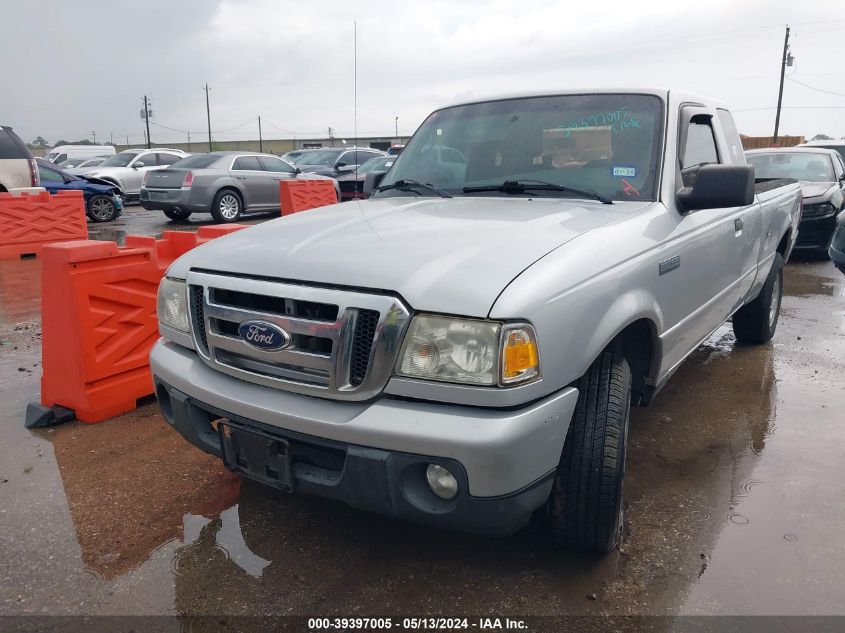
[{"left": 0, "top": 0, "right": 845, "bottom": 144}]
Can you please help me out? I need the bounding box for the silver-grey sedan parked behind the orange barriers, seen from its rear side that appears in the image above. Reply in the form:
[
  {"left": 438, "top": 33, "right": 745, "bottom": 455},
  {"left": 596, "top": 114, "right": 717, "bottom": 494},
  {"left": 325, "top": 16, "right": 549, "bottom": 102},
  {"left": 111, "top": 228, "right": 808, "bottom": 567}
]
[{"left": 141, "top": 152, "right": 340, "bottom": 223}]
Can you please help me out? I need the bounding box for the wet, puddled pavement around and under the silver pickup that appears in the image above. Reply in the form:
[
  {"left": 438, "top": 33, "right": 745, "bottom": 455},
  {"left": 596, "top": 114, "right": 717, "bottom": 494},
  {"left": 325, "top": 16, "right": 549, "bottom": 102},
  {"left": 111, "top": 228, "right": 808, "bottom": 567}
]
[{"left": 0, "top": 207, "right": 845, "bottom": 616}]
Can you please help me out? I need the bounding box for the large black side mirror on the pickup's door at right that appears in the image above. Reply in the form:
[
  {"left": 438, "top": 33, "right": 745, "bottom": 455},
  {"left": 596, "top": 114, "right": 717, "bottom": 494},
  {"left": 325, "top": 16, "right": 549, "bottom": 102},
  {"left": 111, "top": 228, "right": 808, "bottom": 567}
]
[{"left": 678, "top": 165, "right": 754, "bottom": 211}]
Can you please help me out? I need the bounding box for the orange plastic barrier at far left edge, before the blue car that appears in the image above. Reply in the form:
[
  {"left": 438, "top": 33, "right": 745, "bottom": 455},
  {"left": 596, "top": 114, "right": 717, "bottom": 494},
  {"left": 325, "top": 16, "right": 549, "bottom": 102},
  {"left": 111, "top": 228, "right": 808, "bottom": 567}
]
[{"left": 0, "top": 191, "right": 88, "bottom": 259}]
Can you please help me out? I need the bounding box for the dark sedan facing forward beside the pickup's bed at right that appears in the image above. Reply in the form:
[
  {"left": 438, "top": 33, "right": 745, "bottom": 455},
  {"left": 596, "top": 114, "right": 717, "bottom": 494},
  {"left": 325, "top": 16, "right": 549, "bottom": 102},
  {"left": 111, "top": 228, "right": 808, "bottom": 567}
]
[{"left": 745, "top": 146, "right": 845, "bottom": 254}]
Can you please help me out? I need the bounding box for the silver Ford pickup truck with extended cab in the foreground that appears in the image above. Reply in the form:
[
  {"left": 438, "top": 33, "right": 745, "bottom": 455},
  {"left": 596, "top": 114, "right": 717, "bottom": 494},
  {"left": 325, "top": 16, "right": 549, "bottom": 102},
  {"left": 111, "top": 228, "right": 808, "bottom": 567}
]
[{"left": 151, "top": 90, "right": 801, "bottom": 552}]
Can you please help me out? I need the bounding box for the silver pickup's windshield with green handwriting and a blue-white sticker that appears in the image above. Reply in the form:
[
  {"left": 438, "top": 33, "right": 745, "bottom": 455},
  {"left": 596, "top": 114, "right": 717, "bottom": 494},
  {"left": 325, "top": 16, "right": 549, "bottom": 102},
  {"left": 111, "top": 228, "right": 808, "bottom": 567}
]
[{"left": 378, "top": 94, "right": 662, "bottom": 200}]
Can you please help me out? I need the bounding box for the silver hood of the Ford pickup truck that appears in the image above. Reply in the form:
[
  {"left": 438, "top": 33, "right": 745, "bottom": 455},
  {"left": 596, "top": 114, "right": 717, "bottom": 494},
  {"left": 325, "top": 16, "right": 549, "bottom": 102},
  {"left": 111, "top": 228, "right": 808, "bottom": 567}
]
[{"left": 168, "top": 197, "right": 651, "bottom": 317}]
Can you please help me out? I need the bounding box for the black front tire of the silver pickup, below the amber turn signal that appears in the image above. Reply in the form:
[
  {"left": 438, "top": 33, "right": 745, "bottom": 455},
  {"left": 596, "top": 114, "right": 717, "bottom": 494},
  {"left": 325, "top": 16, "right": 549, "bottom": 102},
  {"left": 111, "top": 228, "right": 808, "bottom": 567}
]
[{"left": 548, "top": 352, "right": 631, "bottom": 554}]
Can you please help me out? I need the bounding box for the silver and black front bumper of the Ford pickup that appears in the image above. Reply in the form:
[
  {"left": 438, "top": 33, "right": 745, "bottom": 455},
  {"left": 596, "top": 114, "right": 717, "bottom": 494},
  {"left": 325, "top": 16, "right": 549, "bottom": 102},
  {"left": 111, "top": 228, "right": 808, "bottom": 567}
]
[{"left": 150, "top": 341, "right": 578, "bottom": 534}]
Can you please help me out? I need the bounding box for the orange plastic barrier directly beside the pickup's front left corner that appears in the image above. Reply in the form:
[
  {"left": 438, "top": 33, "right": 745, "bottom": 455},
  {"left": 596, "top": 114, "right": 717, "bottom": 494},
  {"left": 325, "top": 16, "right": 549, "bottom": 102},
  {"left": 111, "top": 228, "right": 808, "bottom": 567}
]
[{"left": 41, "top": 224, "right": 245, "bottom": 422}]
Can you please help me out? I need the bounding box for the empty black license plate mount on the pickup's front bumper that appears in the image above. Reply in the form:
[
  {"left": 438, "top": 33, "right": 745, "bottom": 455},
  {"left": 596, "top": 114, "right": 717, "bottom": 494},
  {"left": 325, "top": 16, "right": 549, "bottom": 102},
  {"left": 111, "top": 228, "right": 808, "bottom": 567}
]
[{"left": 217, "top": 422, "right": 293, "bottom": 492}]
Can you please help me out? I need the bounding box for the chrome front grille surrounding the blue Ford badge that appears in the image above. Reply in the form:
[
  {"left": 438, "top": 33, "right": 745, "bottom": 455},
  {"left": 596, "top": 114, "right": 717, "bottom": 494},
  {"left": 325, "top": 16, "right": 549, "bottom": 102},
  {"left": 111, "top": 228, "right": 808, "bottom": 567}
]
[{"left": 188, "top": 271, "right": 409, "bottom": 400}]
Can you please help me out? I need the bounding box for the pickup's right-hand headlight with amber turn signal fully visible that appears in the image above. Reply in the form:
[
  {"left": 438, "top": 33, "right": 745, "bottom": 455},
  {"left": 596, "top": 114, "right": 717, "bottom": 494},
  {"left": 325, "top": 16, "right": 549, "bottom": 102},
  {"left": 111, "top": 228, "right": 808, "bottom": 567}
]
[{"left": 397, "top": 315, "right": 540, "bottom": 386}]
